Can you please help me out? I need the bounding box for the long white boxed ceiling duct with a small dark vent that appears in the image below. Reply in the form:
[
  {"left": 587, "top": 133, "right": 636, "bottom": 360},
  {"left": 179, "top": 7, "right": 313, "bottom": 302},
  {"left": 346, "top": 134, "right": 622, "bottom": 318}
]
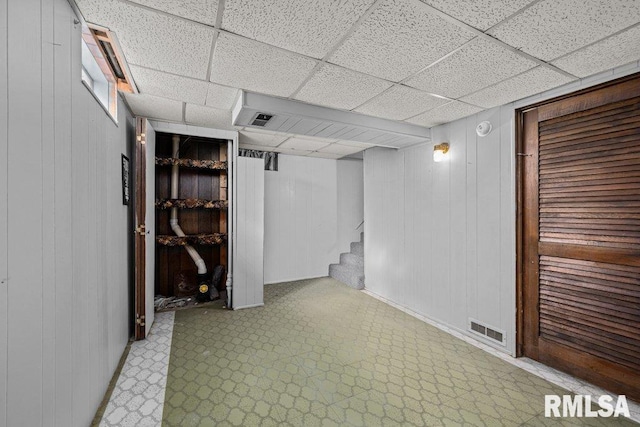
[{"left": 232, "top": 91, "right": 431, "bottom": 148}]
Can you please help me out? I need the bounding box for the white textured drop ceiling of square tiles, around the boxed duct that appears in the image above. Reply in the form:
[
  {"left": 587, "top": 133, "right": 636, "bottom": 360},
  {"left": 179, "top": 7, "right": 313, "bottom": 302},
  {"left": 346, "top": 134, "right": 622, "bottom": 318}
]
[{"left": 75, "top": 0, "right": 640, "bottom": 158}]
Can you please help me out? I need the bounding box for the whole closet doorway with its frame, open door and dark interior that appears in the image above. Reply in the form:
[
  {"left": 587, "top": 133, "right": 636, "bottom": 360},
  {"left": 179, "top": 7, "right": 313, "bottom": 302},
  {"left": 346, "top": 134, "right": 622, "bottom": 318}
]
[{"left": 133, "top": 118, "right": 236, "bottom": 340}]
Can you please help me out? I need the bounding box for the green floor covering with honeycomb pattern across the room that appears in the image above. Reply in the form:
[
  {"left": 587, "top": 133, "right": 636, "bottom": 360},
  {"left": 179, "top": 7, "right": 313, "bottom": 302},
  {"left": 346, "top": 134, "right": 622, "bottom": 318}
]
[{"left": 163, "top": 278, "right": 635, "bottom": 427}]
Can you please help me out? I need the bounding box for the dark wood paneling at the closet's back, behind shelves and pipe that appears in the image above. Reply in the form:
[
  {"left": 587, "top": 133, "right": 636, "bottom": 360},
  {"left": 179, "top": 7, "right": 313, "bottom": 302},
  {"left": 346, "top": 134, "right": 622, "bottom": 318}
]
[{"left": 151, "top": 133, "right": 227, "bottom": 296}]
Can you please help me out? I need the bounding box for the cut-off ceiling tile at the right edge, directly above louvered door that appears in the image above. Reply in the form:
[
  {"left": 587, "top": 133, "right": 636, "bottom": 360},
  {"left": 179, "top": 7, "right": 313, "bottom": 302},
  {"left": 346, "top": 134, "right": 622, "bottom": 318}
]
[{"left": 553, "top": 26, "right": 640, "bottom": 77}]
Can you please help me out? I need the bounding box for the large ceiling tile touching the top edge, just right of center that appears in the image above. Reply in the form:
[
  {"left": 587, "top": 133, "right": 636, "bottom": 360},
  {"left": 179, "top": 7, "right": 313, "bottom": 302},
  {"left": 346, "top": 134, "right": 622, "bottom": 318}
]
[{"left": 330, "top": 0, "right": 473, "bottom": 82}]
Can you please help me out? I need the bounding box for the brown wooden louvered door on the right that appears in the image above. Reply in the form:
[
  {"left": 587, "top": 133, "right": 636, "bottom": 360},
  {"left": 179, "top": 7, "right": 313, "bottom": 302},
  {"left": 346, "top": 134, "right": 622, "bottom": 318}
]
[{"left": 519, "top": 74, "right": 640, "bottom": 400}]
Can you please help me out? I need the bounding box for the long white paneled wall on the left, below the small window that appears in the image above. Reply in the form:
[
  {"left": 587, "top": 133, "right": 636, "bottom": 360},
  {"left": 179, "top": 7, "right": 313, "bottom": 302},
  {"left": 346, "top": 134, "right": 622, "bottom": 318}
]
[{"left": 0, "top": 0, "right": 132, "bottom": 426}]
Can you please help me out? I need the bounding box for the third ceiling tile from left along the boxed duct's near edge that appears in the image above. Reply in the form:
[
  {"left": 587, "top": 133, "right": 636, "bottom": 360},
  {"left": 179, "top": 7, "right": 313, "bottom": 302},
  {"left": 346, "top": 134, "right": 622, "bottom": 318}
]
[{"left": 354, "top": 86, "right": 449, "bottom": 120}]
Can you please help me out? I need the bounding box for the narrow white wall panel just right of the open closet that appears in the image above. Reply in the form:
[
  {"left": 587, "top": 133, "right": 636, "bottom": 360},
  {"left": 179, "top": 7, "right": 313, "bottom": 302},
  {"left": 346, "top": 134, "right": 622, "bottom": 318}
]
[{"left": 232, "top": 157, "right": 265, "bottom": 309}]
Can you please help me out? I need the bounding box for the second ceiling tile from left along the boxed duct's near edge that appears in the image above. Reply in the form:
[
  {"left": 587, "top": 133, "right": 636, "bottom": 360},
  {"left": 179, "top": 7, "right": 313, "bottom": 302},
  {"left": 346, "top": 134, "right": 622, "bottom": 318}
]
[{"left": 295, "top": 64, "right": 393, "bottom": 110}]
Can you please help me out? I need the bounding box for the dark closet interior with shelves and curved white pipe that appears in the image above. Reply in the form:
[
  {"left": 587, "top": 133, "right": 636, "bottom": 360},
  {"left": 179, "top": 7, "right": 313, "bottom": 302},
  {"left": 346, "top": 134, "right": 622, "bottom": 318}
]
[{"left": 155, "top": 132, "right": 229, "bottom": 300}]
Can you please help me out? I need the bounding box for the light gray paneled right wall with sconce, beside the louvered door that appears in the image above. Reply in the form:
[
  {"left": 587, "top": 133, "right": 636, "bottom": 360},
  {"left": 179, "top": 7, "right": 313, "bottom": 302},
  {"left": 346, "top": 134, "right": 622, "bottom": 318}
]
[{"left": 365, "top": 107, "right": 515, "bottom": 352}]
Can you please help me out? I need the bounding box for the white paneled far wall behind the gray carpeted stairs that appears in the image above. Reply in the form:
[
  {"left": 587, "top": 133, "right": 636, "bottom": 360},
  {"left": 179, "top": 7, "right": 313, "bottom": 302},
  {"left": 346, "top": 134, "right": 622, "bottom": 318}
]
[{"left": 264, "top": 155, "right": 363, "bottom": 283}]
